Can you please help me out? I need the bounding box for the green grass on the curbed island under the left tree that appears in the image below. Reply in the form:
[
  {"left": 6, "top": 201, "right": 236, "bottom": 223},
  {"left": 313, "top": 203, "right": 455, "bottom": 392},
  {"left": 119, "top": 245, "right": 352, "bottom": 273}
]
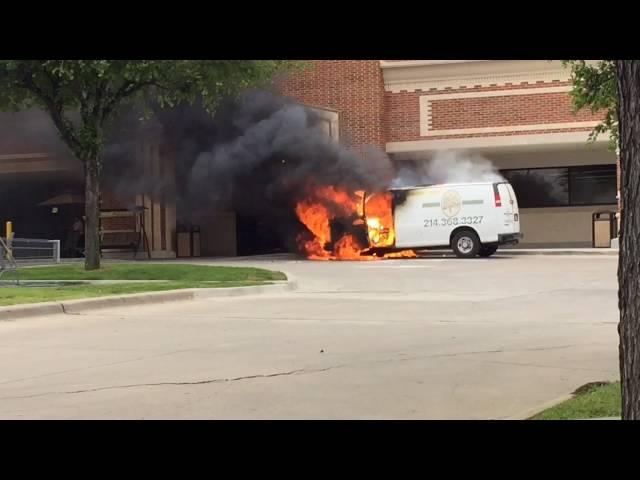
[{"left": 0, "top": 264, "right": 286, "bottom": 305}]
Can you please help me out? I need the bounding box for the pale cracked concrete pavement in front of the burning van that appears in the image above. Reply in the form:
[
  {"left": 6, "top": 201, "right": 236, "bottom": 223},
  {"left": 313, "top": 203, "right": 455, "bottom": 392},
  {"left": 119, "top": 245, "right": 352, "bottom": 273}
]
[{"left": 0, "top": 255, "right": 618, "bottom": 419}]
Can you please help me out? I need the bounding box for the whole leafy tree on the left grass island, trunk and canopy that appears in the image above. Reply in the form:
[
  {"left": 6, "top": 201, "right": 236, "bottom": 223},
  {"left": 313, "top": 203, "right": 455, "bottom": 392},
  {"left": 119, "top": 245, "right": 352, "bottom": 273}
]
[{"left": 0, "top": 60, "right": 293, "bottom": 270}]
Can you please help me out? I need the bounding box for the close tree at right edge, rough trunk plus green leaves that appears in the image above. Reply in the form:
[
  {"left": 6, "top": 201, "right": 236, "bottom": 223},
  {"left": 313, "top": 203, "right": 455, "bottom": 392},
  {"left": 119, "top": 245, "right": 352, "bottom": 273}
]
[{"left": 567, "top": 60, "right": 640, "bottom": 420}]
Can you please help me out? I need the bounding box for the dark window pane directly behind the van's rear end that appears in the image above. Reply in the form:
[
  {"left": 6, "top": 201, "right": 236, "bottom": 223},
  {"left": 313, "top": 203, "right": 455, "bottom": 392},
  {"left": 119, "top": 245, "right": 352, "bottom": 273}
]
[{"left": 502, "top": 168, "right": 569, "bottom": 208}]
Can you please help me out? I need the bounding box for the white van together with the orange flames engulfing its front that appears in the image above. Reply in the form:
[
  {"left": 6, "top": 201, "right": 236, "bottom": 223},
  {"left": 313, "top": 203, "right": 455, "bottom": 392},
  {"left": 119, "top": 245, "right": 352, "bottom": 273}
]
[{"left": 296, "top": 182, "right": 521, "bottom": 260}]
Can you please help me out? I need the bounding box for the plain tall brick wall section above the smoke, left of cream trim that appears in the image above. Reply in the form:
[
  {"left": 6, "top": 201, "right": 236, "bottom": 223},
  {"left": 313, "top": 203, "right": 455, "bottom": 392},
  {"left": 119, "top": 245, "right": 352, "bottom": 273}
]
[{"left": 277, "top": 60, "right": 386, "bottom": 149}]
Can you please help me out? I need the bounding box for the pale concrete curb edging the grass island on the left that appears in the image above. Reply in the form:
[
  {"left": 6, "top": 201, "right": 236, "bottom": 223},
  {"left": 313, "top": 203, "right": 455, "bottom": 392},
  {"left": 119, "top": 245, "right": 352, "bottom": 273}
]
[{"left": 0, "top": 272, "right": 298, "bottom": 321}]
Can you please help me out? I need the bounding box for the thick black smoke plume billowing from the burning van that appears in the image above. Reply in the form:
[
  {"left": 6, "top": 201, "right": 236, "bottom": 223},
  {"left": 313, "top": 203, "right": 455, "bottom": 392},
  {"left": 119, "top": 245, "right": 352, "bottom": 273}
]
[{"left": 104, "top": 91, "right": 394, "bottom": 253}]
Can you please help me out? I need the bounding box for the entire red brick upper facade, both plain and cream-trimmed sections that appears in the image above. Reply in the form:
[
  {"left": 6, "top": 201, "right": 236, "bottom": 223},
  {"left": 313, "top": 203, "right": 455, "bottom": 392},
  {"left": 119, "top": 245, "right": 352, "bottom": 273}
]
[{"left": 278, "top": 60, "right": 604, "bottom": 154}]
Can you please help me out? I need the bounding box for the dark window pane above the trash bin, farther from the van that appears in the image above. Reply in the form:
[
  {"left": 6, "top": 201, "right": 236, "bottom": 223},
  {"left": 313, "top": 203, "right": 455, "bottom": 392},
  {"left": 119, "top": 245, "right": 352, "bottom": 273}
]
[{"left": 569, "top": 165, "right": 617, "bottom": 205}]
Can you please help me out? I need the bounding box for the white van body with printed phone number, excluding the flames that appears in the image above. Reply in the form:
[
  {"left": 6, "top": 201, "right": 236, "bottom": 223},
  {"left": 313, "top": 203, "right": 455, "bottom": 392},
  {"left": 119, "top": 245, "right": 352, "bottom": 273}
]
[{"left": 365, "top": 182, "right": 521, "bottom": 258}]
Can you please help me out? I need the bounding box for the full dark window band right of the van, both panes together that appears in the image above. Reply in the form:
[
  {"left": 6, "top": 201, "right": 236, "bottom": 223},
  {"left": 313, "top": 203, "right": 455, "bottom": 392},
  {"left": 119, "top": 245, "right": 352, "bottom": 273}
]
[{"left": 501, "top": 165, "right": 616, "bottom": 208}]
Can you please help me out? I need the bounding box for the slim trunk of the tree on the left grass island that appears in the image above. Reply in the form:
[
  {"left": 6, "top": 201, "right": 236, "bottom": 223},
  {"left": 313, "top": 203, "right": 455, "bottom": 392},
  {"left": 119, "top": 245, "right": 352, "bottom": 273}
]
[{"left": 84, "top": 158, "right": 100, "bottom": 270}]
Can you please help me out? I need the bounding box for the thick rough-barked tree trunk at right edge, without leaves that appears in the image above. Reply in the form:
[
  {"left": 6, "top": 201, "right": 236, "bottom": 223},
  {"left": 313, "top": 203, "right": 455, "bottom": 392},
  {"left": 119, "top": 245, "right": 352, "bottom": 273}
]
[{"left": 616, "top": 60, "right": 640, "bottom": 420}]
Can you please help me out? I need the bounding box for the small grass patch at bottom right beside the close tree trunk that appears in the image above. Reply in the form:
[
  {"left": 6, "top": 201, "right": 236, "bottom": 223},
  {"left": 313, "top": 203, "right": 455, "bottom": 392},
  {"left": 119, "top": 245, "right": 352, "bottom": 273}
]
[{"left": 533, "top": 382, "right": 622, "bottom": 420}]
